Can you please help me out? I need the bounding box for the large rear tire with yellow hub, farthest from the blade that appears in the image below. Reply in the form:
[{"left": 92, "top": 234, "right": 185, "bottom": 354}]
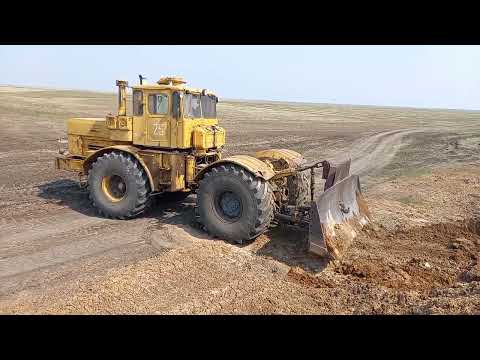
[{"left": 88, "top": 151, "right": 150, "bottom": 219}]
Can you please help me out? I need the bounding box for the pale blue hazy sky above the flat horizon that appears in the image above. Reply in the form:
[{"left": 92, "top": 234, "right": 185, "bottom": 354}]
[{"left": 0, "top": 45, "right": 480, "bottom": 110}]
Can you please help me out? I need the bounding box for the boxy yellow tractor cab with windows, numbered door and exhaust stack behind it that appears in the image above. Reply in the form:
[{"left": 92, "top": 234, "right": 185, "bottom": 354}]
[{"left": 122, "top": 77, "right": 225, "bottom": 152}]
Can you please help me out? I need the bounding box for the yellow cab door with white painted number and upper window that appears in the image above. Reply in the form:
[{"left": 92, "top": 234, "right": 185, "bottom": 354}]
[{"left": 145, "top": 90, "right": 172, "bottom": 147}]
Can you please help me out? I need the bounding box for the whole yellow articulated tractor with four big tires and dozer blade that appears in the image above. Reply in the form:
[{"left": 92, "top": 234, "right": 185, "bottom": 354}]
[{"left": 55, "top": 76, "right": 370, "bottom": 258}]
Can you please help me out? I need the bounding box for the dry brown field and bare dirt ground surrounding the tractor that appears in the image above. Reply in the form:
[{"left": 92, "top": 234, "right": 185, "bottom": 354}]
[{"left": 0, "top": 86, "right": 480, "bottom": 314}]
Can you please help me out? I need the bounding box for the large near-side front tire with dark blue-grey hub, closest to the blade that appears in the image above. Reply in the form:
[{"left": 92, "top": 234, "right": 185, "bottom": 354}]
[{"left": 197, "top": 164, "right": 274, "bottom": 244}]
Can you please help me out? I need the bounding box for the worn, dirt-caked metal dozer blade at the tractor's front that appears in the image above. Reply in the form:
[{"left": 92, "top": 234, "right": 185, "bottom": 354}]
[{"left": 309, "top": 175, "right": 371, "bottom": 259}]
